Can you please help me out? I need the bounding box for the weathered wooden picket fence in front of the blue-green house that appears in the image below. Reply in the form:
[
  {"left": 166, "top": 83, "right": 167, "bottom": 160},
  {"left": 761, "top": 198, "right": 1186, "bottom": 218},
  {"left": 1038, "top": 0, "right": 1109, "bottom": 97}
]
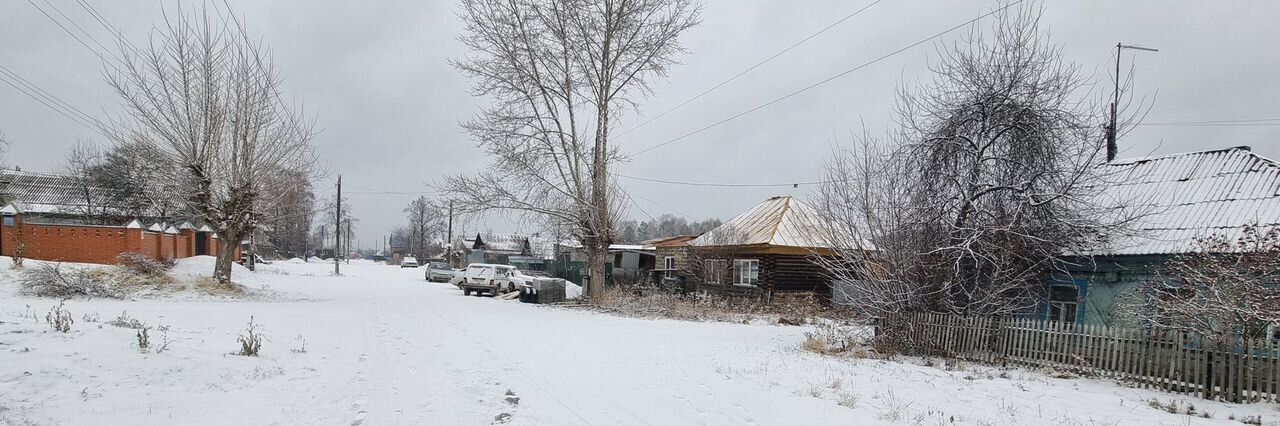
[{"left": 877, "top": 312, "right": 1280, "bottom": 403}]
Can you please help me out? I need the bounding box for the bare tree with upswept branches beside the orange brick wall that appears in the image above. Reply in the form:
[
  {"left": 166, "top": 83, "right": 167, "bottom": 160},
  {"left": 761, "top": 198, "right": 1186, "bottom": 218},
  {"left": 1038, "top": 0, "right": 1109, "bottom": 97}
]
[{"left": 106, "top": 4, "right": 315, "bottom": 284}]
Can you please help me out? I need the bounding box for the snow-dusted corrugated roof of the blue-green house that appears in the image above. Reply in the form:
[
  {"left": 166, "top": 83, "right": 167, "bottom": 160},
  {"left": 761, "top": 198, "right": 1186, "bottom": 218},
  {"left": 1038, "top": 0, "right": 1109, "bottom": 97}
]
[{"left": 1093, "top": 147, "right": 1280, "bottom": 255}]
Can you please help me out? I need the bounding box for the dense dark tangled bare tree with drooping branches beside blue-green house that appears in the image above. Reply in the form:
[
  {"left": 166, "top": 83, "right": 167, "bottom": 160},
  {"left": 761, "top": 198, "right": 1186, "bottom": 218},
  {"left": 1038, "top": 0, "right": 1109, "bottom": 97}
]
[{"left": 819, "top": 5, "right": 1133, "bottom": 315}]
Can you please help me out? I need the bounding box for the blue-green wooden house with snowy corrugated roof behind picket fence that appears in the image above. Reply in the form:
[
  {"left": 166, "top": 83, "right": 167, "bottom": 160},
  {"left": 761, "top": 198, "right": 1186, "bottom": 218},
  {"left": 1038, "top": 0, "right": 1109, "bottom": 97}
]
[{"left": 1041, "top": 147, "right": 1280, "bottom": 324}]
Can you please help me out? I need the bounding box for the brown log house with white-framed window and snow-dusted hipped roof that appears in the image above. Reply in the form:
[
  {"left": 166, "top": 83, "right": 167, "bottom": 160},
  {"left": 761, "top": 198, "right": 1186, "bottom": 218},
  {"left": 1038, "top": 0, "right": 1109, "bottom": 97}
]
[{"left": 686, "top": 196, "right": 832, "bottom": 299}]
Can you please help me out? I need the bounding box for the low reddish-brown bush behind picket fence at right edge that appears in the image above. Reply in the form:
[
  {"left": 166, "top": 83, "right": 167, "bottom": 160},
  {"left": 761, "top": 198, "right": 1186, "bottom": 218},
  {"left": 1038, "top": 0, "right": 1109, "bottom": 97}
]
[{"left": 1124, "top": 224, "right": 1280, "bottom": 347}]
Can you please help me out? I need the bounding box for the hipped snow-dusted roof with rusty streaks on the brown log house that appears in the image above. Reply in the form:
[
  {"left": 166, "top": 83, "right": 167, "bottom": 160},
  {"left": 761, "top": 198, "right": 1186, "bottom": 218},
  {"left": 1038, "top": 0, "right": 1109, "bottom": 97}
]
[{"left": 689, "top": 196, "right": 828, "bottom": 248}]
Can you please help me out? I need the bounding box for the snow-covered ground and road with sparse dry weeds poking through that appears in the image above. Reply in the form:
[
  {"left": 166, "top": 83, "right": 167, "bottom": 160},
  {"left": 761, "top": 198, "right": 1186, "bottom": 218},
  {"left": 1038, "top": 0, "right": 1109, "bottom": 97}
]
[{"left": 0, "top": 258, "right": 1280, "bottom": 425}]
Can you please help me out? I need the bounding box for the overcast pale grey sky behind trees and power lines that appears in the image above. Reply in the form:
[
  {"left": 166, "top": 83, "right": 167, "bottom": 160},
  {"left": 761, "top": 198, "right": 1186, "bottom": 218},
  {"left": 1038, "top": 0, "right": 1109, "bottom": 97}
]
[{"left": 0, "top": 0, "right": 1280, "bottom": 247}]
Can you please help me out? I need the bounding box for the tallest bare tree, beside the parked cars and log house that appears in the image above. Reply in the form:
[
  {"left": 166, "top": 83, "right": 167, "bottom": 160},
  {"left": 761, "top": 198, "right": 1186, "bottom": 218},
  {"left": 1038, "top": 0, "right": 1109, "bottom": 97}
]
[{"left": 436, "top": 0, "right": 699, "bottom": 296}]
